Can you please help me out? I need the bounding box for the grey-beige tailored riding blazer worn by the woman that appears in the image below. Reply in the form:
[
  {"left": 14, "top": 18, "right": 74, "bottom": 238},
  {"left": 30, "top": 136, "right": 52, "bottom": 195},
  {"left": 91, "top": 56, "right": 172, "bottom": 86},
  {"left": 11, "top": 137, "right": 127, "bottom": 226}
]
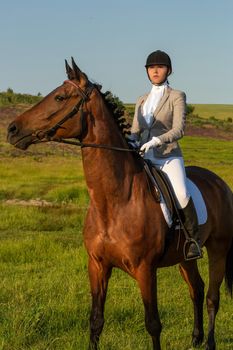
[{"left": 131, "top": 86, "right": 186, "bottom": 158}]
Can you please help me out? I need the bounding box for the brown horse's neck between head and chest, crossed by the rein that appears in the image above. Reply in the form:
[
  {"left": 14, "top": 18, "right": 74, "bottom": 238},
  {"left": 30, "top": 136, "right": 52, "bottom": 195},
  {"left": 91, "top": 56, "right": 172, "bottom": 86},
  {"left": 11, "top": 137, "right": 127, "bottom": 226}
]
[{"left": 82, "top": 94, "right": 139, "bottom": 206}]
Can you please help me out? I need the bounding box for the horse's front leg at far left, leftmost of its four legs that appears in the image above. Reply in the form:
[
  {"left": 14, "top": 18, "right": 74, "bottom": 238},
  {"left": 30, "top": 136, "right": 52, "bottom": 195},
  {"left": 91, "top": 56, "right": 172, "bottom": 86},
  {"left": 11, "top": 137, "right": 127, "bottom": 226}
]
[{"left": 88, "top": 257, "right": 112, "bottom": 350}]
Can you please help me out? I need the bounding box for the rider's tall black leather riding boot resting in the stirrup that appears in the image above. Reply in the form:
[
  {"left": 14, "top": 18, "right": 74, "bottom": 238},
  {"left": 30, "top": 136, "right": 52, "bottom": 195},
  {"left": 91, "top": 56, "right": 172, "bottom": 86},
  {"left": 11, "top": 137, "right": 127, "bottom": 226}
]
[{"left": 182, "top": 197, "right": 202, "bottom": 260}]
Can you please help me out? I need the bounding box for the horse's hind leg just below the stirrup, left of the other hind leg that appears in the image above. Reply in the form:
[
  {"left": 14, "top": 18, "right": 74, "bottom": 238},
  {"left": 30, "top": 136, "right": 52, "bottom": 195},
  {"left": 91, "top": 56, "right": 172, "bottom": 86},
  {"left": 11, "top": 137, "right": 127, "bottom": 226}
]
[{"left": 179, "top": 260, "right": 204, "bottom": 347}]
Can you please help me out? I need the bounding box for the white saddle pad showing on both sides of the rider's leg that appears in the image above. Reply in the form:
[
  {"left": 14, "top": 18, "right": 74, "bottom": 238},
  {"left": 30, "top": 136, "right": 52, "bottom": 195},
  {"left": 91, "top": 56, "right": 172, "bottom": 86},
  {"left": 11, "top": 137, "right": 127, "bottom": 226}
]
[{"left": 160, "top": 178, "right": 207, "bottom": 227}]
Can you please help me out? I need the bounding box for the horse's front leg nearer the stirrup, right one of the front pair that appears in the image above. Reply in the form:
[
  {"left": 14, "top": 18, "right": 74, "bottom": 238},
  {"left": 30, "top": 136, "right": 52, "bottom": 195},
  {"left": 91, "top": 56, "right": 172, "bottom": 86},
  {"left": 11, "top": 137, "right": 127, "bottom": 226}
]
[{"left": 136, "top": 265, "right": 162, "bottom": 350}]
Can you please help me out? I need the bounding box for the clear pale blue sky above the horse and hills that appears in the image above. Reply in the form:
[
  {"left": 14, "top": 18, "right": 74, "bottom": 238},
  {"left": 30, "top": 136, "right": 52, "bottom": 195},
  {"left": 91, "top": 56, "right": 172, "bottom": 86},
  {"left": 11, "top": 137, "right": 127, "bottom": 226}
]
[{"left": 0, "top": 0, "right": 233, "bottom": 104}]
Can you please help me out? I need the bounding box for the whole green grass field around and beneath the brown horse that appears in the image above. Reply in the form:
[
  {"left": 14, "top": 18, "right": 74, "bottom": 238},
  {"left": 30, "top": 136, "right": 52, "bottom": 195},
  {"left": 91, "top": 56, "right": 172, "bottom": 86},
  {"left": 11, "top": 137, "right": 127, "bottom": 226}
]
[{"left": 0, "top": 137, "right": 233, "bottom": 350}]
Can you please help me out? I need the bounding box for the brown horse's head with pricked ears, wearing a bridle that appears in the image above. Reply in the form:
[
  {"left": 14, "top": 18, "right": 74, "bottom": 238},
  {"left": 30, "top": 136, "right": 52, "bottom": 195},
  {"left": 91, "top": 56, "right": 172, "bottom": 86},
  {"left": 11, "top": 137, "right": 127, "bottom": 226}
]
[{"left": 8, "top": 58, "right": 93, "bottom": 149}]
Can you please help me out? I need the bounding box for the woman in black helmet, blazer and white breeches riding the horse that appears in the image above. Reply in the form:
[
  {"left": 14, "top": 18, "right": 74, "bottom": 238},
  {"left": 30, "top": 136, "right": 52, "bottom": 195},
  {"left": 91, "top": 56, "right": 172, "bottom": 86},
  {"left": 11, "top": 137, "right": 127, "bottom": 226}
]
[{"left": 130, "top": 50, "right": 202, "bottom": 260}]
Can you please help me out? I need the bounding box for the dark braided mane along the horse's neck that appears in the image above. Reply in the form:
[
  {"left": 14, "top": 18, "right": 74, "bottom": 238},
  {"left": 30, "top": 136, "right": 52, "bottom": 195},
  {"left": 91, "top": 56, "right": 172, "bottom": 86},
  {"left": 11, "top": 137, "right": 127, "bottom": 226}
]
[{"left": 94, "top": 84, "right": 131, "bottom": 137}]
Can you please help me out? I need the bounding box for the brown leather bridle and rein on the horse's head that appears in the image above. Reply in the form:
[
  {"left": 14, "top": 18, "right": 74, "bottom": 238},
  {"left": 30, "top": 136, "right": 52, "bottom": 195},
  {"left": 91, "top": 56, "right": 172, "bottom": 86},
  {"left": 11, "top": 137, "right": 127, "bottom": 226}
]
[{"left": 34, "top": 80, "right": 138, "bottom": 152}]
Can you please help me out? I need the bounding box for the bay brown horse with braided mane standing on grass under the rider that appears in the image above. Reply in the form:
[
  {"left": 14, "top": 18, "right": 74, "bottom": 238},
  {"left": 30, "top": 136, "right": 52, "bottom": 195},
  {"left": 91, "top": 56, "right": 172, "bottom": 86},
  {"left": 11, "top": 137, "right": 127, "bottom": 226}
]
[{"left": 8, "top": 59, "right": 233, "bottom": 350}]
